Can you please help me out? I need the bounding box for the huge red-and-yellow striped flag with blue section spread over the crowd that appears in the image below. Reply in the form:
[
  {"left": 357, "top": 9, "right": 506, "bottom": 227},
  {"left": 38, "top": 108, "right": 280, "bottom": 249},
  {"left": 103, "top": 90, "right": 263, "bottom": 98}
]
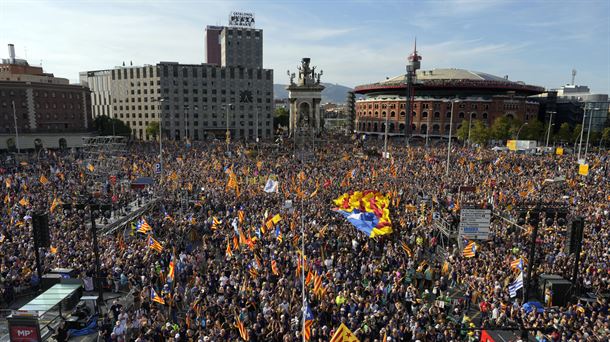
[{"left": 333, "top": 190, "right": 392, "bottom": 237}]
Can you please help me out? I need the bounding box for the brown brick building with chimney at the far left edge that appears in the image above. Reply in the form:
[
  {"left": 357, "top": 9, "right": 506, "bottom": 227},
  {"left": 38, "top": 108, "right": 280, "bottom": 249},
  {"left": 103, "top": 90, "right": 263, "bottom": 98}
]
[{"left": 0, "top": 44, "right": 92, "bottom": 150}]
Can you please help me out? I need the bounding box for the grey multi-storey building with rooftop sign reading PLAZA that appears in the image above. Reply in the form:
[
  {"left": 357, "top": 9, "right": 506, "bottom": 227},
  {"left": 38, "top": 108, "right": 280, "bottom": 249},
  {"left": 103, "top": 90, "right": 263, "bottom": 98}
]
[{"left": 80, "top": 13, "right": 275, "bottom": 140}]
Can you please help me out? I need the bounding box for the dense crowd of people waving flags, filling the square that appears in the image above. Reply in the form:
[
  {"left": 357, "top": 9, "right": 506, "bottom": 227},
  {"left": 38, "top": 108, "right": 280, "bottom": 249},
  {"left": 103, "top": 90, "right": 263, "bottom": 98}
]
[{"left": 0, "top": 141, "right": 610, "bottom": 341}]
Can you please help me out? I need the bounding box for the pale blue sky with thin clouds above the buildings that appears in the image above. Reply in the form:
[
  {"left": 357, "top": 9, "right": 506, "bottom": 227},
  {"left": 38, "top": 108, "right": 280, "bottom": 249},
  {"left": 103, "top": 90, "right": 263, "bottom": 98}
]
[{"left": 0, "top": 0, "right": 610, "bottom": 93}]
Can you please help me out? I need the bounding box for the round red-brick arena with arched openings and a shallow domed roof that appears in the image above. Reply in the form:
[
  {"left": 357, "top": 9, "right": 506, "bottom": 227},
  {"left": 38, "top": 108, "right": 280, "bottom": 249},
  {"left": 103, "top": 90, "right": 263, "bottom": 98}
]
[{"left": 355, "top": 69, "right": 544, "bottom": 138}]
